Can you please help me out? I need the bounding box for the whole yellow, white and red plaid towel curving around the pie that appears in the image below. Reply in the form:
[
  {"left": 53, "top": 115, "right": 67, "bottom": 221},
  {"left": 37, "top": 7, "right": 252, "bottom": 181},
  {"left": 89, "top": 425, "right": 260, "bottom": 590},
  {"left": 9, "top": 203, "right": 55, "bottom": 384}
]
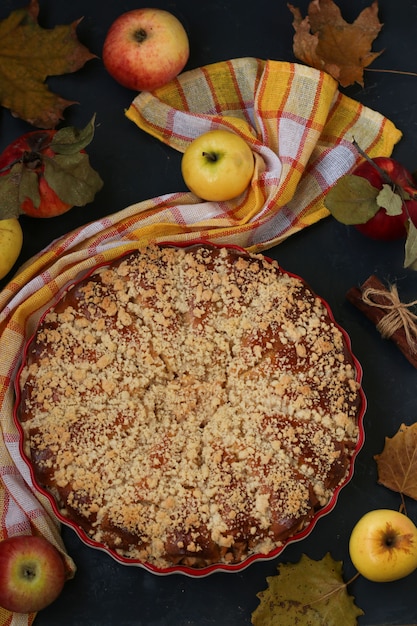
[{"left": 0, "top": 58, "right": 401, "bottom": 626}]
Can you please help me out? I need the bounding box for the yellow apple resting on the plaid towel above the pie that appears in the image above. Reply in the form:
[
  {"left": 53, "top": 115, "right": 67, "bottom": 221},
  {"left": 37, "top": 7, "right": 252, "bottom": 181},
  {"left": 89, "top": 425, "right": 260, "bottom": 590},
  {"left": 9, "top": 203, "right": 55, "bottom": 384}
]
[{"left": 181, "top": 129, "right": 255, "bottom": 202}]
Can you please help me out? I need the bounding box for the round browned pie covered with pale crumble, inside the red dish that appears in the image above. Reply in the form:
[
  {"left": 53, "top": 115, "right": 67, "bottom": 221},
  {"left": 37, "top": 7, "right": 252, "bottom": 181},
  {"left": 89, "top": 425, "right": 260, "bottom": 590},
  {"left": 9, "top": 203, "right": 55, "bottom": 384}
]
[{"left": 20, "top": 246, "right": 360, "bottom": 567}]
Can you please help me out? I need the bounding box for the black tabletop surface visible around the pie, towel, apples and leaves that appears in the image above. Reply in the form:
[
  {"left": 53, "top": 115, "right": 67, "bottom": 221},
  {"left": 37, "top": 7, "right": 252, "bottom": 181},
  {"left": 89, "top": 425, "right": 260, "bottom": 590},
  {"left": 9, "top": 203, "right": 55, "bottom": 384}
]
[{"left": 0, "top": 0, "right": 417, "bottom": 626}]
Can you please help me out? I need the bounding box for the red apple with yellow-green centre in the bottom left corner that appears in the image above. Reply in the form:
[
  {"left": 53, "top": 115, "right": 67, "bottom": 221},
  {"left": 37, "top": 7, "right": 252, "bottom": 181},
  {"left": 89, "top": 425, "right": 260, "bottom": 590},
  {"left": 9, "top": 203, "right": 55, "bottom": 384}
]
[{"left": 0, "top": 535, "right": 66, "bottom": 613}]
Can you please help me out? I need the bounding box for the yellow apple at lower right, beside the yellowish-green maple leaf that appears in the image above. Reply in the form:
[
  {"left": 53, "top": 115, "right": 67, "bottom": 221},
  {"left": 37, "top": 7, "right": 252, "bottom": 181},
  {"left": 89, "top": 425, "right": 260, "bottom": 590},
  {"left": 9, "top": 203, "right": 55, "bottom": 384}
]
[{"left": 349, "top": 509, "right": 417, "bottom": 582}]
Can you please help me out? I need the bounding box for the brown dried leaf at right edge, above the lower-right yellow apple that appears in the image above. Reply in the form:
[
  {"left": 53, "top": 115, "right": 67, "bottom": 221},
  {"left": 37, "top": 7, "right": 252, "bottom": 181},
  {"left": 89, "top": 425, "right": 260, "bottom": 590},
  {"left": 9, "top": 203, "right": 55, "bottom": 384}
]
[{"left": 374, "top": 423, "right": 417, "bottom": 500}]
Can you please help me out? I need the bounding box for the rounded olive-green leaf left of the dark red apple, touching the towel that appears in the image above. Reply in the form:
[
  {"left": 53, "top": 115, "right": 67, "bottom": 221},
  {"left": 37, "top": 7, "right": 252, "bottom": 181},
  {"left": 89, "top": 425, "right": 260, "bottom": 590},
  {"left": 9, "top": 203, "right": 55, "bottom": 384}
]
[{"left": 324, "top": 174, "right": 380, "bottom": 226}]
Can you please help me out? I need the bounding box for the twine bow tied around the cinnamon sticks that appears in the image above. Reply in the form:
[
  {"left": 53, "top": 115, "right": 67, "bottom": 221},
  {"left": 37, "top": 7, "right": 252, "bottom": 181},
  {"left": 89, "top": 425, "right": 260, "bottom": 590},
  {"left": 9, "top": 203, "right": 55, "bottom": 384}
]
[{"left": 362, "top": 285, "right": 417, "bottom": 352}]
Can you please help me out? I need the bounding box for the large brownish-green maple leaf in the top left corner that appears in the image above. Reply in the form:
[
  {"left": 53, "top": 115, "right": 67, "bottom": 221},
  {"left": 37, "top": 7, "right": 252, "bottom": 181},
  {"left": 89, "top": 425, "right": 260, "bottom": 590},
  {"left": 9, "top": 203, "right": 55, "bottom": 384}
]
[{"left": 0, "top": 0, "right": 95, "bottom": 129}]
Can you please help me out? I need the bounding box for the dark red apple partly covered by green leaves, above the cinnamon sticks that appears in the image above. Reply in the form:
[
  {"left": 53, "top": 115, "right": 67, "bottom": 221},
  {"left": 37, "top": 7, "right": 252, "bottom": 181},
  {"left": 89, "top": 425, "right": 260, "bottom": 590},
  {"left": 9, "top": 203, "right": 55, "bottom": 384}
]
[{"left": 353, "top": 157, "right": 417, "bottom": 240}]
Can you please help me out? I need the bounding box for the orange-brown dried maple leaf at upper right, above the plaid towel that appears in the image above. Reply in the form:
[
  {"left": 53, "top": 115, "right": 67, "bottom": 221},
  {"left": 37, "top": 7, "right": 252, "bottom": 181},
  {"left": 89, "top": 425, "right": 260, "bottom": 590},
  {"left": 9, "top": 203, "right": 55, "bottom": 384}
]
[{"left": 288, "top": 0, "right": 382, "bottom": 87}]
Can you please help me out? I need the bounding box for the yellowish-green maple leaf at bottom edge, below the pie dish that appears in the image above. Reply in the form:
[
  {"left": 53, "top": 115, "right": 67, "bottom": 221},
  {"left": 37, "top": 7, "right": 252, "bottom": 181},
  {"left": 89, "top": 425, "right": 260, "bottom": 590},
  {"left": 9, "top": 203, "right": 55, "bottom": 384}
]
[{"left": 252, "top": 553, "right": 363, "bottom": 626}]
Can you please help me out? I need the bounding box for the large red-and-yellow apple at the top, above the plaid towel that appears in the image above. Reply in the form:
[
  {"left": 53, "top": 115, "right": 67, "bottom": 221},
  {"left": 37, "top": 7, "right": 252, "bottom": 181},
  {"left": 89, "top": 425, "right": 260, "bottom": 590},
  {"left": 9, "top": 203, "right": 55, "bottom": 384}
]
[{"left": 102, "top": 8, "right": 189, "bottom": 91}]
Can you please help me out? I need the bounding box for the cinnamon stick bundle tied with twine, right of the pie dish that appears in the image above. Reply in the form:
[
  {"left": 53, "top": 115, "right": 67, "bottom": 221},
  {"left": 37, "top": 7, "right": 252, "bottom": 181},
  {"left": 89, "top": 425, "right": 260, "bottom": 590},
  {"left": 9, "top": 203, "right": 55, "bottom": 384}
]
[{"left": 346, "top": 275, "right": 417, "bottom": 368}]
